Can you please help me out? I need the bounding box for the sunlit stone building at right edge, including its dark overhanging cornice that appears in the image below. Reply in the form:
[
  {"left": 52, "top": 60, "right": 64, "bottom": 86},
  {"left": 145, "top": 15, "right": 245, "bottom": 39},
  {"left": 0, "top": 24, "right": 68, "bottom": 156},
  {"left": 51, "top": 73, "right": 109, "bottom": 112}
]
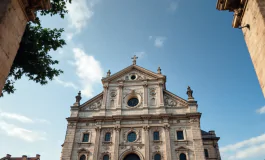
[{"left": 216, "top": 0, "right": 265, "bottom": 96}]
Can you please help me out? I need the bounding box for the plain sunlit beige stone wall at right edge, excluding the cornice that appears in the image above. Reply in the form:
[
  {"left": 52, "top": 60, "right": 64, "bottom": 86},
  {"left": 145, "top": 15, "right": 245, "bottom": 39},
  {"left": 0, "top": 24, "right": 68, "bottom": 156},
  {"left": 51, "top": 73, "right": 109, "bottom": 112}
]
[{"left": 241, "top": 0, "right": 265, "bottom": 96}]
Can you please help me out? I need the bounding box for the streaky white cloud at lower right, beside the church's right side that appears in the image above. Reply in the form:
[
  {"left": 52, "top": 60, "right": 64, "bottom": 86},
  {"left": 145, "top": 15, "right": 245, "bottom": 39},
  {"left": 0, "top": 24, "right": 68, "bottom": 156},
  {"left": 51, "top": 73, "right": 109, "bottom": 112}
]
[{"left": 220, "top": 134, "right": 265, "bottom": 160}]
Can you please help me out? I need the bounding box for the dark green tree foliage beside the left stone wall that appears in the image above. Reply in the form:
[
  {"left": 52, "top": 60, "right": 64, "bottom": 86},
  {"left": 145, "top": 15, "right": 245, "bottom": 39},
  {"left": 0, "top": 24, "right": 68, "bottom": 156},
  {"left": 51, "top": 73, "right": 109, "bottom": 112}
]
[{"left": 2, "top": 0, "right": 71, "bottom": 95}]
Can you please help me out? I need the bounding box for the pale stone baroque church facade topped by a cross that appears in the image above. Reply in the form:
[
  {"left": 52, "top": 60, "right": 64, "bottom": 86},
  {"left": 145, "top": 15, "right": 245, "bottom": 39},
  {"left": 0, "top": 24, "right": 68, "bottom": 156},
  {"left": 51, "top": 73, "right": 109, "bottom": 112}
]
[{"left": 61, "top": 57, "right": 221, "bottom": 160}]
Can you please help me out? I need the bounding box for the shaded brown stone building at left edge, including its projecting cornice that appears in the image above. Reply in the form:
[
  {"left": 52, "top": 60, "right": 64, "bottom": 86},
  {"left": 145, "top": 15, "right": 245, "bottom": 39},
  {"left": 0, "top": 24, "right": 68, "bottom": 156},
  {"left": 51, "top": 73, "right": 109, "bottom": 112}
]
[{"left": 0, "top": 0, "right": 50, "bottom": 93}]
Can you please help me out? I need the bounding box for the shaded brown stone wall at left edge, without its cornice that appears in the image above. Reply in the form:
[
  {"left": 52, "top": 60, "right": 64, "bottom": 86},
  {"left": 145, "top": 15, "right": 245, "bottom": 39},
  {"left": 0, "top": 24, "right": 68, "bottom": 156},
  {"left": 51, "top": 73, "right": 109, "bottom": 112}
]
[{"left": 0, "top": 0, "right": 27, "bottom": 93}]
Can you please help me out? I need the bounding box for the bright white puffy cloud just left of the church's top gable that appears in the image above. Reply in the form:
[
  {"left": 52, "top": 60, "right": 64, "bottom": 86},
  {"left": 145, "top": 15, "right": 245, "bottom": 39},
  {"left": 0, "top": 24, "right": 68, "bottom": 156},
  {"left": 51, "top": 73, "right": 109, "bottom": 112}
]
[{"left": 73, "top": 48, "right": 103, "bottom": 98}]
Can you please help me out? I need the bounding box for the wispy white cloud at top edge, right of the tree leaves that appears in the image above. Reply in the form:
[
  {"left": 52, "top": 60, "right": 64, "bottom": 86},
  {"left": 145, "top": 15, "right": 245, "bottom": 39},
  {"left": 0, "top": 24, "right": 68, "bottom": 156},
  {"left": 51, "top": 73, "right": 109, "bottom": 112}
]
[{"left": 67, "top": 0, "right": 97, "bottom": 32}]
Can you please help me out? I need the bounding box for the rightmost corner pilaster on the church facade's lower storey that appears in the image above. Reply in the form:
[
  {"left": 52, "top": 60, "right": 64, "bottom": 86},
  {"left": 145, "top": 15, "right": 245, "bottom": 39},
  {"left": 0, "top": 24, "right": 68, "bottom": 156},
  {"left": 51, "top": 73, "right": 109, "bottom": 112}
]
[{"left": 190, "top": 116, "right": 205, "bottom": 160}]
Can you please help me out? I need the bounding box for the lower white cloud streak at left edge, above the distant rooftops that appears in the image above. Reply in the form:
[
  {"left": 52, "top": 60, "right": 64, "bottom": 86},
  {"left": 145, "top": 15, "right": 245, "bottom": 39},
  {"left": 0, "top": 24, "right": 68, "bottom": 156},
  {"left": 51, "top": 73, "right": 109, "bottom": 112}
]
[{"left": 0, "top": 121, "right": 46, "bottom": 142}]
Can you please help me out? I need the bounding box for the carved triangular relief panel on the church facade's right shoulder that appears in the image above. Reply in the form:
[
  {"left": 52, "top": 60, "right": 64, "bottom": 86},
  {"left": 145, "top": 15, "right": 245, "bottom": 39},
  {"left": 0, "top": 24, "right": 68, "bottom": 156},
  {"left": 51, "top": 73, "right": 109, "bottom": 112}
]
[{"left": 164, "top": 90, "right": 188, "bottom": 107}]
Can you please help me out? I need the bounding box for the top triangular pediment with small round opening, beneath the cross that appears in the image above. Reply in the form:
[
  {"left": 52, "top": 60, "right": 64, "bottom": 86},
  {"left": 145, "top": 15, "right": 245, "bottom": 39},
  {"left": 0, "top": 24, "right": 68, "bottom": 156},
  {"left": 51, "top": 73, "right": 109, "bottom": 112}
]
[{"left": 102, "top": 65, "right": 166, "bottom": 82}]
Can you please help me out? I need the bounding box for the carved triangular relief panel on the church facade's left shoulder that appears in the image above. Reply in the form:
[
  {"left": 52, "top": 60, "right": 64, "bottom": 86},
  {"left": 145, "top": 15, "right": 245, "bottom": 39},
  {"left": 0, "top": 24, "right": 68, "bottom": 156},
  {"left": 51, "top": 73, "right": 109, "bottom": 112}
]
[{"left": 79, "top": 92, "right": 103, "bottom": 111}]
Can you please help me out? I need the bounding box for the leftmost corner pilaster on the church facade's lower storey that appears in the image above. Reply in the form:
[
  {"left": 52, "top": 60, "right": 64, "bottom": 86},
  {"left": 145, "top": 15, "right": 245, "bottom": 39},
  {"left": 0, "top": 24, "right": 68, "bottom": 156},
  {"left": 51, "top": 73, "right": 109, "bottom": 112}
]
[{"left": 61, "top": 122, "right": 77, "bottom": 160}]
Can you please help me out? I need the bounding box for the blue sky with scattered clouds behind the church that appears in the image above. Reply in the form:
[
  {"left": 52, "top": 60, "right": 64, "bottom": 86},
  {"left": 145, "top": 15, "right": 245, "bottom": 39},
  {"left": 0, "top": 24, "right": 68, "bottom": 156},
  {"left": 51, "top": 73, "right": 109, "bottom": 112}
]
[{"left": 0, "top": 0, "right": 265, "bottom": 160}]
